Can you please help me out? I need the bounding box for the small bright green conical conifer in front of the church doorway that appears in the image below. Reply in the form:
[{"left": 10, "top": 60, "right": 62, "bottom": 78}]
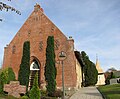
[{"left": 29, "top": 72, "right": 40, "bottom": 99}]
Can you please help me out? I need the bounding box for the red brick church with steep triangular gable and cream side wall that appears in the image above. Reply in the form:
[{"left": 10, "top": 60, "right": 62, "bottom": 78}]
[{"left": 3, "top": 4, "right": 82, "bottom": 89}]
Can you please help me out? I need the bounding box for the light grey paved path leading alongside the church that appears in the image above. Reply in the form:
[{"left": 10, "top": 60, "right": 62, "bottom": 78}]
[{"left": 70, "top": 87, "right": 103, "bottom": 99}]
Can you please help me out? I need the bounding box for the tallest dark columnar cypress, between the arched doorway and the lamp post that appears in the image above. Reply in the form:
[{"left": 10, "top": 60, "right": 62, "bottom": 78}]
[{"left": 44, "top": 36, "right": 57, "bottom": 96}]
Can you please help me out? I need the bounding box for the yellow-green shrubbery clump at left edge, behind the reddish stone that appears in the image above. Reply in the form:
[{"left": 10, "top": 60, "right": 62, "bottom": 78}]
[{"left": 0, "top": 67, "right": 15, "bottom": 93}]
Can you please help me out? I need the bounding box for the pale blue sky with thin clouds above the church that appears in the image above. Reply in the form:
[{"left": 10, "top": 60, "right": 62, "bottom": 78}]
[{"left": 0, "top": 0, "right": 120, "bottom": 71}]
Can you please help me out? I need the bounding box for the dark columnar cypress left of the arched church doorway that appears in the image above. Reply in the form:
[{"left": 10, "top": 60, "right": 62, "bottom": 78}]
[{"left": 18, "top": 41, "right": 30, "bottom": 88}]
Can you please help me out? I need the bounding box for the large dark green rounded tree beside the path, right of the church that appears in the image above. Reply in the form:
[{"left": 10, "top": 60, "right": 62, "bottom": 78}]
[{"left": 81, "top": 51, "right": 98, "bottom": 86}]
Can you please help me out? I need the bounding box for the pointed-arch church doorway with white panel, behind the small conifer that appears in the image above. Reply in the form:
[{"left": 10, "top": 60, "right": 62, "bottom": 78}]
[{"left": 28, "top": 59, "right": 40, "bottom": 90}]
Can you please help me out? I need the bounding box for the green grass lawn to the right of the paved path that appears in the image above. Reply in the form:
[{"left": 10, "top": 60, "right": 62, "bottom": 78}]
[{"left": 98, "top": 84, "right": 120, "bottom": 99}]
